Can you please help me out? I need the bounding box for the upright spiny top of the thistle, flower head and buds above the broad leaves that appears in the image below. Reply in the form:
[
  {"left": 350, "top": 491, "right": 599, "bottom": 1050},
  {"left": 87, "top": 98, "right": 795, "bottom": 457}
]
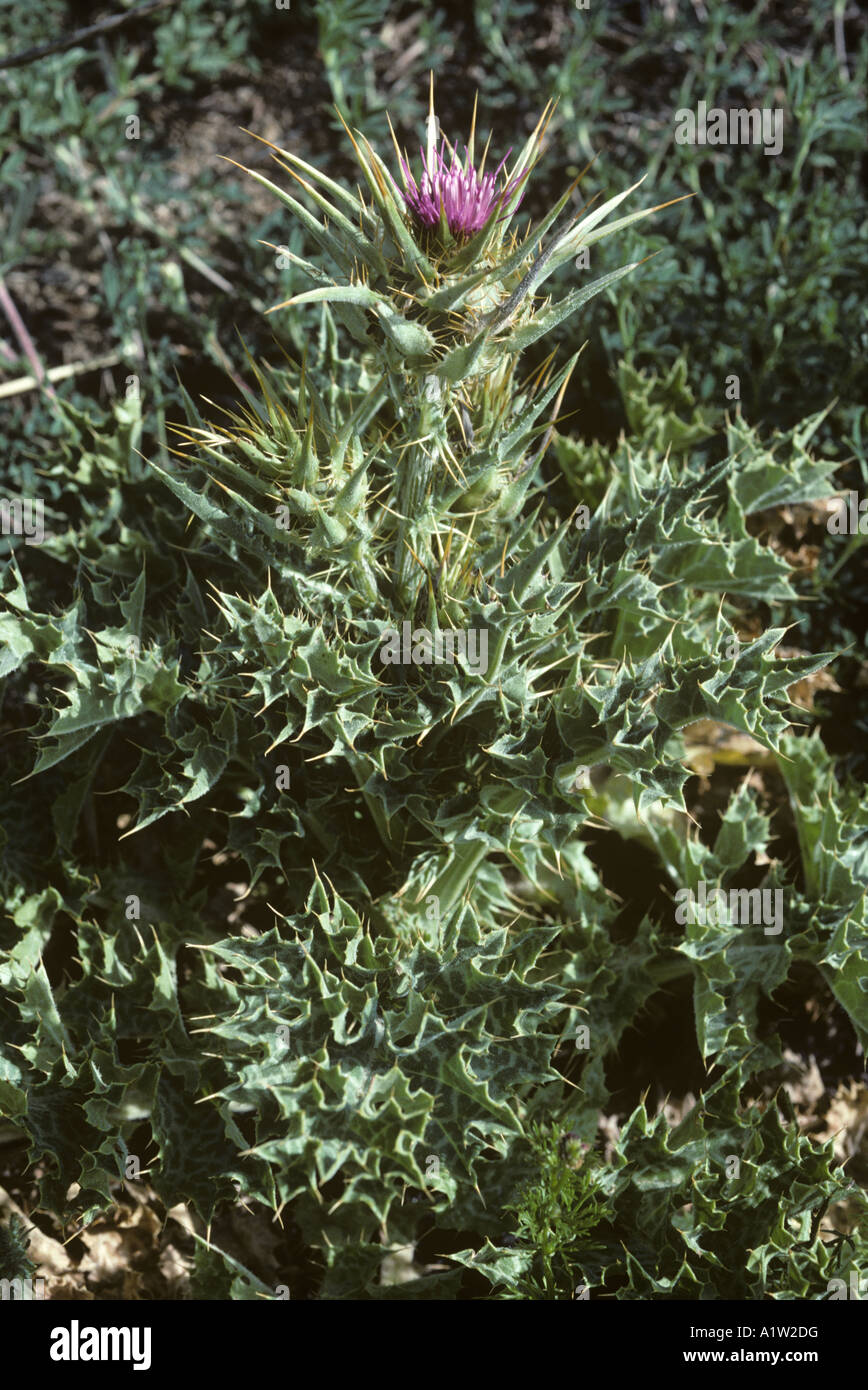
[{"left": 193, "top": 89, "right": 676, "bottom": 608}]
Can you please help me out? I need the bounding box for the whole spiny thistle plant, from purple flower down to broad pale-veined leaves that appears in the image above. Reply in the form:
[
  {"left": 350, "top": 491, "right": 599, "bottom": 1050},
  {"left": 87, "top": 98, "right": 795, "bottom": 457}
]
[{"left": 0, "top": 81, "right": 868, "bottom": 1298}]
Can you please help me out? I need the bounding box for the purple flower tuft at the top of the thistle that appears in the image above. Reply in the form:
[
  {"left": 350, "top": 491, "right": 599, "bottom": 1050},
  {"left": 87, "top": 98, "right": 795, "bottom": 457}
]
[{"left": 401, "top": 139, "right": 526, "bottom": 236}]
